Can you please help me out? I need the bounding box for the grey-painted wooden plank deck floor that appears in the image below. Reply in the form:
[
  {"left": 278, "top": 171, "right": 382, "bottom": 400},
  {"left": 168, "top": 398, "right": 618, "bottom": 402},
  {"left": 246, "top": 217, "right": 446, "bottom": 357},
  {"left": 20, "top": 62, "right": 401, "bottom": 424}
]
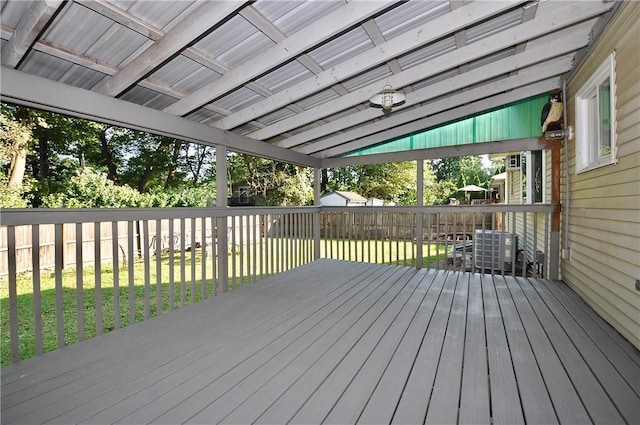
[{"left": 2, "top": 260, "right": 640, "bottom": 424}]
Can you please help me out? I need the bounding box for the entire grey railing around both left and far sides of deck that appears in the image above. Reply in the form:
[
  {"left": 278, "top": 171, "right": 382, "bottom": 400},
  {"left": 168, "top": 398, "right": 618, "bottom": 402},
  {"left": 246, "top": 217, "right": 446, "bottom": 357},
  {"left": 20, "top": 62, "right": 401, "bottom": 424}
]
[{"left": 0, "top": 205, "right": 558, "bottom": 364}]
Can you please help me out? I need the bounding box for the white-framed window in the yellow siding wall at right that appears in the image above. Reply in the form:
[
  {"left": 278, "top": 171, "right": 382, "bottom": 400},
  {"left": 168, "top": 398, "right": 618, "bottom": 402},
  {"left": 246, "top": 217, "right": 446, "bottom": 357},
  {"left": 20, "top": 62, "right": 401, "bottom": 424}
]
[{"left": 576, "top": 52, "right": 616, "bottom": 172}]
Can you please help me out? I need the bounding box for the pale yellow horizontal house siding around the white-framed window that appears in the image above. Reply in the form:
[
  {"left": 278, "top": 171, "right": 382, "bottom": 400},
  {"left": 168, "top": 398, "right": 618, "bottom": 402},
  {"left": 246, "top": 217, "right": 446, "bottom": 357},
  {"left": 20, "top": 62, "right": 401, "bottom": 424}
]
[{"left": 561, "top": 2, "right": 640, "bottom": 348}]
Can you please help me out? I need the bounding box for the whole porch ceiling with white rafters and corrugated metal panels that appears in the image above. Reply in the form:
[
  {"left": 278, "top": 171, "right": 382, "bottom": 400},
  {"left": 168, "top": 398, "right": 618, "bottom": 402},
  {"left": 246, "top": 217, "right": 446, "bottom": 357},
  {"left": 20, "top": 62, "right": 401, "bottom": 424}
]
[{"left": 0, "top": 0, "right": 616, "bottom": 165}]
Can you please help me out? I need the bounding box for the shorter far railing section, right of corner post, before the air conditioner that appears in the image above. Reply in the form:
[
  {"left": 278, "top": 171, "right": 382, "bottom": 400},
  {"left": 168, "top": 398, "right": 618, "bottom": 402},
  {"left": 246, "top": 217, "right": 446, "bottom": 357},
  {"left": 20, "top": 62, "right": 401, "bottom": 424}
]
[{"left": 320, "top": 204, "right": 557, "bottom": 277}]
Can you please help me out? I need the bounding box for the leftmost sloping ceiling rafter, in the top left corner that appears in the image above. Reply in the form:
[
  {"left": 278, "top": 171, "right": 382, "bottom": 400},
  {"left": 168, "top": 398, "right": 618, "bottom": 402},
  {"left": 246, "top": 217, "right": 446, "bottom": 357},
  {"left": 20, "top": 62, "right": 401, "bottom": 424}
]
[{"left": 2, "top": 0, "right": 63, "bottom": 68}]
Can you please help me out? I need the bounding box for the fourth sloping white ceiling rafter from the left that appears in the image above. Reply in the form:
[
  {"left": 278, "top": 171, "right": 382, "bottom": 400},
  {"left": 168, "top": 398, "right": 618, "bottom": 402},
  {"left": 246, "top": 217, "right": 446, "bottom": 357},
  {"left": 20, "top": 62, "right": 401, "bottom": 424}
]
[{"left": 216, "top": 2, "right": 516, "bottom": 131}]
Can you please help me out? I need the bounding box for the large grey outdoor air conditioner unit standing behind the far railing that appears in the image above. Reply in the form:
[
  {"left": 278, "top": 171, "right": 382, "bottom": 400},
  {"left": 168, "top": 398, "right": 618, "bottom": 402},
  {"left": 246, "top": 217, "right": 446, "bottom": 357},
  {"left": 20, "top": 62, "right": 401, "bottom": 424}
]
[{"left": 473, "top": 230, "right": 518, "bottom": 271}]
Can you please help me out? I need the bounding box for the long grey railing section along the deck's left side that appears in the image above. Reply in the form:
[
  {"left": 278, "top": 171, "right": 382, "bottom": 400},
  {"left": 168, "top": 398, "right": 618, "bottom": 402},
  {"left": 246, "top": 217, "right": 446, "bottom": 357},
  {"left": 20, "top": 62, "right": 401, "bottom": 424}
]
[{"left": 0, "top": 208, "right": 318, "bottom": 364}]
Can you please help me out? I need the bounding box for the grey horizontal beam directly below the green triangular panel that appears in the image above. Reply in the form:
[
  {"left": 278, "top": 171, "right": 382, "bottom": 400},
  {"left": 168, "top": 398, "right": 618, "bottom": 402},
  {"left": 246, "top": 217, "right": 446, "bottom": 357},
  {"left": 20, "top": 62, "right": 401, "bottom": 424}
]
[{"left": 322, "top": 138, "right": 552, "bottom": 168}]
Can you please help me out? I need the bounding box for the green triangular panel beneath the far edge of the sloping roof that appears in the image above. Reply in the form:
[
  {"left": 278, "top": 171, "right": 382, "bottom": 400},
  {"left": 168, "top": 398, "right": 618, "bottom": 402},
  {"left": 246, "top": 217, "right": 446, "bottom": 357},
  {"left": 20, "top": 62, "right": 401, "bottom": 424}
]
[{"left": 341, "top": 93, "right": 549, "bottom": 156}]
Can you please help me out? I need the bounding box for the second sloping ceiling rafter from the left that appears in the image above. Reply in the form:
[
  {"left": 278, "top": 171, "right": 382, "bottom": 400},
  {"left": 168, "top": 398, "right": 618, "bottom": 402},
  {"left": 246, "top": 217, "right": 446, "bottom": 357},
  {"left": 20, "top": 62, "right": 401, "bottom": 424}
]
[{"left": 96, "top": 1, "right": 246, "bottom": 96}]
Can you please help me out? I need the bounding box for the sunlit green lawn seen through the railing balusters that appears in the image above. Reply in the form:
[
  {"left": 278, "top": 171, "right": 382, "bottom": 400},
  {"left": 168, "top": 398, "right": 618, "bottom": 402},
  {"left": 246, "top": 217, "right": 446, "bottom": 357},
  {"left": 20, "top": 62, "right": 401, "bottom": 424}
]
[{"left": 0, "top": 240, "right": 444, "bottom": 366}]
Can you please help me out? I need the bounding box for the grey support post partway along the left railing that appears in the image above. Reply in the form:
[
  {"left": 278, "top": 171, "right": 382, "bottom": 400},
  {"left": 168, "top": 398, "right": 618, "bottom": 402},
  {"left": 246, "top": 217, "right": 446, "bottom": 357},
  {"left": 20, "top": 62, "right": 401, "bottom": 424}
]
[{"left": 214, "top": 145, "right": 229, "bottom": 293}]
